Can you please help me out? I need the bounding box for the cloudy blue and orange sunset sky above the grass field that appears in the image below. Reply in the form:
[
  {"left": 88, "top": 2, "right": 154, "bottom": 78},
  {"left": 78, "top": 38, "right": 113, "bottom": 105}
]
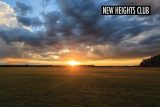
[{"left": 0, "top": 0, "right": 160, "bottom": 66}]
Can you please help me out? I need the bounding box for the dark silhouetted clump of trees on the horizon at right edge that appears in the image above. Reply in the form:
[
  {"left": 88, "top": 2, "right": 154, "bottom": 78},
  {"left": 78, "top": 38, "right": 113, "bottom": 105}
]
[{"left": 140, "top": 55, "right": 160, "bottom": 67}]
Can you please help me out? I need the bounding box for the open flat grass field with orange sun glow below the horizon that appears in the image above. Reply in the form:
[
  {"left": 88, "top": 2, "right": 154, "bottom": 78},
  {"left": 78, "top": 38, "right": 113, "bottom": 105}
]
[{"left": 0, "top": 67, "right": 160, "bottom": 107}]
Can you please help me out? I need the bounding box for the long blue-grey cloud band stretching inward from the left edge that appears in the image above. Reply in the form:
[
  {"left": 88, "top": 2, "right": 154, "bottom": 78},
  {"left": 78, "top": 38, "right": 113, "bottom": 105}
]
[{"left": 0, "top": 26, "right": 67, "bottom": 47}]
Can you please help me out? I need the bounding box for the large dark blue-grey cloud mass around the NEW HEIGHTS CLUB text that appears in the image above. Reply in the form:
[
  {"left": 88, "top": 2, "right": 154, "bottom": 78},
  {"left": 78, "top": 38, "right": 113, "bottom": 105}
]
[{"left": 54, "top": 0, "right": 160, "bottom": 58}]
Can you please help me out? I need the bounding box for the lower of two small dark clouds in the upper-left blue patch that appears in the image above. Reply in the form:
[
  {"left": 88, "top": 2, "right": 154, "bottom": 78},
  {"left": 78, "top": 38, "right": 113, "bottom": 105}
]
[{"left": 17, "top": 16, "right": 42, "bottom": 27}]
